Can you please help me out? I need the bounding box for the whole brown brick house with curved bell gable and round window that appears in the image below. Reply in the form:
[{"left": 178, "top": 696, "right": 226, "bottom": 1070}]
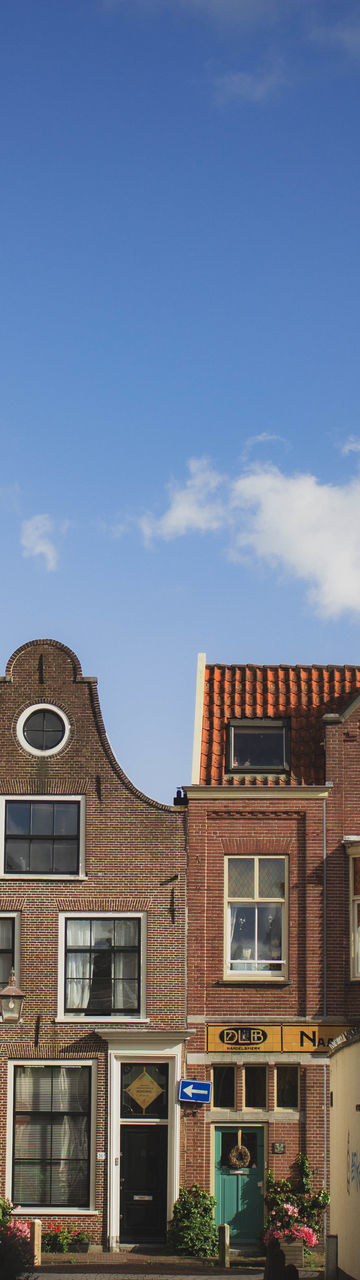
[{"left": 0, "top": 640, "right": 186, "bottom": 1245}]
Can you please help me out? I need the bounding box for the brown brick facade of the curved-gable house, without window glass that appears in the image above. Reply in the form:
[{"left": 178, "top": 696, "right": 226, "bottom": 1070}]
[{"left": 0, "top": 640, "right": 186, "bottom": 1244}]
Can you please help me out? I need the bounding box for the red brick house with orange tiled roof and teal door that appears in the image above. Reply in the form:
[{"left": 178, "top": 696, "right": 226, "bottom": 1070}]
[{"left": 180, "top": 655, "right": 360, "bottom": 1243}]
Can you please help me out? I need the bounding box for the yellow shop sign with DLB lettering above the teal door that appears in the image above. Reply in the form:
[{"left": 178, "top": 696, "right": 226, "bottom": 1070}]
[{"left": 206, "top": 1023, "right": 350, "bottom": 1053}]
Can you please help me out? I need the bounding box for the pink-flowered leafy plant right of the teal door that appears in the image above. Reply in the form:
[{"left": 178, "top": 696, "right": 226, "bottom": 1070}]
[{"left": 264, "top": 1155, "right": 329, "bottom": 1252}]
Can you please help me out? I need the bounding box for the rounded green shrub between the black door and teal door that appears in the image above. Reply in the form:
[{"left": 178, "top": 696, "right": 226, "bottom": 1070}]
[{"left": 168, "top": 1183, "right": 218, "bottom": 1258}]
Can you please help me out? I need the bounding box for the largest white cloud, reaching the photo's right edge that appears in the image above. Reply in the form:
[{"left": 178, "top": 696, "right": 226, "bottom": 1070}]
[{"left": 140, "top": 460, "right": 360, "bottom": 618}]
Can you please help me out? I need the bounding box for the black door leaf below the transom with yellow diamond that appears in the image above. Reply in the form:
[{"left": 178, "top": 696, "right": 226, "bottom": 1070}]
[{"left": 120, "top": 1124, "right": 168, "bottom": 1244}]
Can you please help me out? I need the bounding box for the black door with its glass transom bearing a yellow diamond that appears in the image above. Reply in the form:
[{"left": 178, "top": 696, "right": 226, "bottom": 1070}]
[{"left": 120, "top": 1061, "right": 169, "bottom": 1244}]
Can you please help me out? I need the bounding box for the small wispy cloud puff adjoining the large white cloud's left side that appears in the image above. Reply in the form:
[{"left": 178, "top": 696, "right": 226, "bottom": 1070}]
[{"left": 140, "top": 458, "right": 224, "bottom": 543}]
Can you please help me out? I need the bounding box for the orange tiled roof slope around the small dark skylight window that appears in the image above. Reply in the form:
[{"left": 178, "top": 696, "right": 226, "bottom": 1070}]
[{"left": 200, "top": 664, "right": 360, "bottom": 786}]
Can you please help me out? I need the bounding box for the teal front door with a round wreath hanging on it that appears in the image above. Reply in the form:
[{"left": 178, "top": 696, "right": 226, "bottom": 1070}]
[{"left": 215, "top": 1125, "right": 264, "bottom": 1244}]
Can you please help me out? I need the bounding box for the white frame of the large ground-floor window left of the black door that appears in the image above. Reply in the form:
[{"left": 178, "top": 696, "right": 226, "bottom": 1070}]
[{"left": 5, "top": 1057, "right": 97, "bottom": 1217}]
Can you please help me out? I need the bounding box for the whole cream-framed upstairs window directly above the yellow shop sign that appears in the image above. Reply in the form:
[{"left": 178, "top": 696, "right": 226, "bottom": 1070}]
[{"left": 225, "top": 856, "right": 287, "bottom": 979}]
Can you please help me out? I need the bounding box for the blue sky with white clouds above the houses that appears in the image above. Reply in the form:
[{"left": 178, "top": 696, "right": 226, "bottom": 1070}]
[{"left": 0, "top": 0, "right": 360, "bottom": 803}]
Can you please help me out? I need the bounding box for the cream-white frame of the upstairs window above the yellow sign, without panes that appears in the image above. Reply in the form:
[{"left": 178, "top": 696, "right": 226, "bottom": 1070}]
[{"left": 224, "top": 854, "right": 288, "bottom": 983}]
